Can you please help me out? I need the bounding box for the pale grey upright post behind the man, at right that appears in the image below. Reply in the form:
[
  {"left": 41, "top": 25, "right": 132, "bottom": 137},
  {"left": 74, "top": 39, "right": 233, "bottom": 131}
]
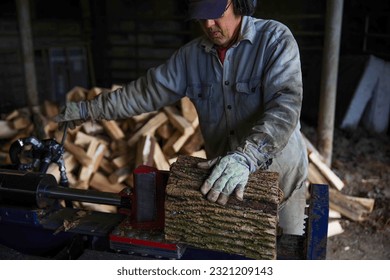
[{"left": 318, "top": 0, "right": 344, "bottom": 166}]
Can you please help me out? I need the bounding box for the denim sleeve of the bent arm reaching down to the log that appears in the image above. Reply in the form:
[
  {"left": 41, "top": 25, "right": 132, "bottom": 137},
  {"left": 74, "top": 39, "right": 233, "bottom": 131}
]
[{"left": 237, "top": 25, "right": 303, "bottom": 172}]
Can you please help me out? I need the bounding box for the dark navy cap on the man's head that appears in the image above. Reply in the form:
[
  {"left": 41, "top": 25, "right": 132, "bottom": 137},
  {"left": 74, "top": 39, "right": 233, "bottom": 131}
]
[{"left": 188, "top": 0, "right": 228, "bottom": 19}]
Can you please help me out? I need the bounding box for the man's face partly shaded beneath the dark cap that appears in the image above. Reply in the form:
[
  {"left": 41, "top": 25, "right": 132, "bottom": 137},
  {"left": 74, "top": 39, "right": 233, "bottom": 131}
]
[{"left": 199, "top": 1, "right": 241, "bottom": 47}]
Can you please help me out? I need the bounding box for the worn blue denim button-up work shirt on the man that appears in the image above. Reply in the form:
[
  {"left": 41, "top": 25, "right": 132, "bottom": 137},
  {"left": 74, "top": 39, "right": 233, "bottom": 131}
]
[{"left": 90, "top": 16, "right": 307, "bottom": 198}]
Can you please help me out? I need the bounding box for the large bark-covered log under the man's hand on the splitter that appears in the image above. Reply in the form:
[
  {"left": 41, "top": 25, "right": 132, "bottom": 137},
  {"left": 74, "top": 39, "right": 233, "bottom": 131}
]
[{"left": 165, "top": 156, "right": 282, "bottom": 259}]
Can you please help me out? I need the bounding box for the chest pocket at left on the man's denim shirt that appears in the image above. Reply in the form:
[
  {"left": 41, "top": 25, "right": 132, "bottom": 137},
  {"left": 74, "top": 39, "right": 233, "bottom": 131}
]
[{"left": 186, "top": 84, "right": 218, "bottom": 124}]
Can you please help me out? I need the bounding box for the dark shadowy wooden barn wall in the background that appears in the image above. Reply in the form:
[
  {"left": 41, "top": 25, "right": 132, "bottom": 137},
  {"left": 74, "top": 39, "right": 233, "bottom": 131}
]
[{"left": 0, "top": 0, "right": 390, "bottom": 127}]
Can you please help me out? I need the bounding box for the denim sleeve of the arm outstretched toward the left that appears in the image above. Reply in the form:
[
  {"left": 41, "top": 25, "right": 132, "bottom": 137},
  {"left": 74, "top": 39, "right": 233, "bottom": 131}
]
[{"left": 88, "top": 50, "right": 186, "bottom": 120}]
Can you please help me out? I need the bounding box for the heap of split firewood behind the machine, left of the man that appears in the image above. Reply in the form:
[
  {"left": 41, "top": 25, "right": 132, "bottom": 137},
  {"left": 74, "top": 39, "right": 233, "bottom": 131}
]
[{"left": 0, "top": 85, "right": 205, "bottom": 212}]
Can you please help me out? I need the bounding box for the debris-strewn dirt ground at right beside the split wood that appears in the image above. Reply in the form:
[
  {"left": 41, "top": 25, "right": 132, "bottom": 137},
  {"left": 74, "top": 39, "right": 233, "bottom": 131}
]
[{"left": 302, "top": 125, "right": 390, "bottom": 260}]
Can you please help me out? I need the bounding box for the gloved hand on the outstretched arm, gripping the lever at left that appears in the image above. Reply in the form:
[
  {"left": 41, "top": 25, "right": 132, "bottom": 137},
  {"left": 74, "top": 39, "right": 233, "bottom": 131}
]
[{"left": 54, "top": 101, "right": 89, "bottom": 129}]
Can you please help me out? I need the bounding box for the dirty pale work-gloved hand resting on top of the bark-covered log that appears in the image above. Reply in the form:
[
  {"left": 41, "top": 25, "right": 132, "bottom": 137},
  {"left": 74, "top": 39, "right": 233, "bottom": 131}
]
[{"left": 198, "top": 153, "right": 250, "bottom": 205}]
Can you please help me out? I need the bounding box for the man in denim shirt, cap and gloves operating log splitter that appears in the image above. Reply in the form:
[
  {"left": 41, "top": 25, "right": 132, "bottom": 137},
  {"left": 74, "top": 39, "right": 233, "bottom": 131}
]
[{"left": 57, "top": 0, "right": 307, "bottom": 234}]
